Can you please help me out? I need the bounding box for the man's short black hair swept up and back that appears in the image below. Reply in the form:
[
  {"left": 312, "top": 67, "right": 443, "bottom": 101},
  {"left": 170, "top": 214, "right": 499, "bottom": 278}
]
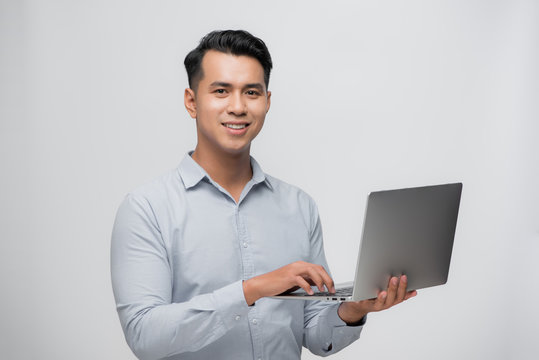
[{"left": 183, "top": 30, "right": 273, "bottom": 89}]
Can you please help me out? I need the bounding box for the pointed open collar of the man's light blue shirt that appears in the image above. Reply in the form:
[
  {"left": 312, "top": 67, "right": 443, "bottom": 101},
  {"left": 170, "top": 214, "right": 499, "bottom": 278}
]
[{"left": 178, "top": 151, "right": 273, "bottom": 190}]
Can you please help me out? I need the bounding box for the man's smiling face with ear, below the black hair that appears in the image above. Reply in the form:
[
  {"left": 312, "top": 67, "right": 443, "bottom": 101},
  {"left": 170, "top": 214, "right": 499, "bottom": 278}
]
[{"left": 185, "top": 50, "right": 271, "bottom": 155}]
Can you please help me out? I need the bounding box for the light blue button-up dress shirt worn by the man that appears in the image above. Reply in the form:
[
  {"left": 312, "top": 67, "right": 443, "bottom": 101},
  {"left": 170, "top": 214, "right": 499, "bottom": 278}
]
[{"left": 111, "top": 154, "right": 362, "bottom": 360}]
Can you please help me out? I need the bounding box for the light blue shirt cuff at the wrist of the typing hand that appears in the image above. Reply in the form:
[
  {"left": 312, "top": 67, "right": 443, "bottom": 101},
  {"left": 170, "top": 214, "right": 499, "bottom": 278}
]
[{"left": 213, "top": 280, "right": 251, "bottom": 329}]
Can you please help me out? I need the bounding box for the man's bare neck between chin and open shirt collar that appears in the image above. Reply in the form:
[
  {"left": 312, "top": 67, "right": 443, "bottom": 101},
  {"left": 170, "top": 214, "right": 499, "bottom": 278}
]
[{"left": 191, "top": 145, "right": 253, "bottom": 202}]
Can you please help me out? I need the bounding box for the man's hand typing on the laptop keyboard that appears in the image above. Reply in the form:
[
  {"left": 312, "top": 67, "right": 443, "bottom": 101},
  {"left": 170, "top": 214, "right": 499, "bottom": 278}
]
[{"left": 243, "top": 261, "right": 335, "bottom": 305}]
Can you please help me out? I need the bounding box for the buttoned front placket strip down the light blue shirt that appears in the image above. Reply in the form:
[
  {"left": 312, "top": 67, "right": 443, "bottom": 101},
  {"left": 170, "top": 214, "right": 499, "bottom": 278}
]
[{"left": 236, "top": 205, "right": 263, "bottom": 360}]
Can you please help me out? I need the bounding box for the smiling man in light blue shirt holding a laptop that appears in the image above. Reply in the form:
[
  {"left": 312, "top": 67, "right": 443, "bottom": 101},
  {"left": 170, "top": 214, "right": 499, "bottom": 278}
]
[{"left": 111, "top": 31, "right": 415, "bottom": 360}]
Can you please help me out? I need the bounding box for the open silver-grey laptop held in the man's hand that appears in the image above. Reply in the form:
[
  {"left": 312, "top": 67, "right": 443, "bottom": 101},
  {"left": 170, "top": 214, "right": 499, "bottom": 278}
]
[{"left": 274, "top": 183, "right": 462, "bottom": 301}]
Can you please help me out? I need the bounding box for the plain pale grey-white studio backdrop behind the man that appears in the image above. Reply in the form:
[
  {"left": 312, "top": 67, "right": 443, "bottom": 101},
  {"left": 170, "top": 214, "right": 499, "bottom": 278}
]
[{"left": 0, "top": 0, "right": 539, "bottom": 360}]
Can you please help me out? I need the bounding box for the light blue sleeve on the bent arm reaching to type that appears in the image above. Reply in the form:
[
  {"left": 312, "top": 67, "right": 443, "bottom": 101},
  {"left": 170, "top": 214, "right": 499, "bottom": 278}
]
[{"left": 111, "top": 196, "right": 253, "bottom": 360}]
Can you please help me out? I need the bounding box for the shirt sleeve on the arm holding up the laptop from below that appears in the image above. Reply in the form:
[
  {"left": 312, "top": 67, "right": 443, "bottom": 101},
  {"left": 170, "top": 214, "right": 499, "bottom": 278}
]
[{"left": 303, "top": 203, "right": 363, "bottom": 356}]
